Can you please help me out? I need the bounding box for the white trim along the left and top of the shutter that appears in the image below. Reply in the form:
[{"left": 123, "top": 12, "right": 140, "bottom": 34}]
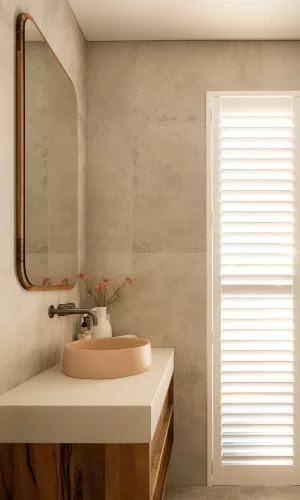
[{"left": 206, "top": 90, "right": 300, "bottom": 486}]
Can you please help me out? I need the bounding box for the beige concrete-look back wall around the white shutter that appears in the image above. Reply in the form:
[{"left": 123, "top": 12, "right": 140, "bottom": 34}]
[{"left": 87, "top": 42, "right": 300, "bottom": 484}]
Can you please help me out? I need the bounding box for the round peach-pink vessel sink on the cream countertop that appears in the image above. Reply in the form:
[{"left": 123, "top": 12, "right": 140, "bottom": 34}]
[{"left": 62, "top": 337, "right": 151, "bottom": 379}]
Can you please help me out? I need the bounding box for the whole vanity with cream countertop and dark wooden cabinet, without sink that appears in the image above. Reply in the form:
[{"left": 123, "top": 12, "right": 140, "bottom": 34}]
[{"left": 0, "top": 348, "right": 174, "bottom": 500}]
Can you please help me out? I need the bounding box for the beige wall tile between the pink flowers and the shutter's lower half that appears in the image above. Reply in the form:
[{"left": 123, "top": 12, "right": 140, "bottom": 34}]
[{"left": 132, "top": 254, "right": 206, "bottom": 383}]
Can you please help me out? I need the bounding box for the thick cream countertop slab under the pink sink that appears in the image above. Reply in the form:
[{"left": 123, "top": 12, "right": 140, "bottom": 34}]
[{"left": 0, "top": 348, "right": 174, "bottom": 443}]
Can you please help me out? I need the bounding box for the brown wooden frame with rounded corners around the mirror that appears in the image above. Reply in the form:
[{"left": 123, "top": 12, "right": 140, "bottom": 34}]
[{"left": 16, "top": 13, "right": 76, "bottom": 292}]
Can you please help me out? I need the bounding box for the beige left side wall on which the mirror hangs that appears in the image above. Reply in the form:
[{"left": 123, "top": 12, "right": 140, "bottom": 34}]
[{"left": 0, "top": 0, "right": 86, "bottom": 393}]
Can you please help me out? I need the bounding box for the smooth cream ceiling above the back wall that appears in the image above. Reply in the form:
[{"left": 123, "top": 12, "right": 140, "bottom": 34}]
[{"left": 69, "top": 0, "right": 300, "bottom": 41}]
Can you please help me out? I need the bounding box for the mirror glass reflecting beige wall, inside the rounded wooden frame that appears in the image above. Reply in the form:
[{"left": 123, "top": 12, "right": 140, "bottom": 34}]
[{"left": 24, "top": 20, "right": 78, "bottom": 286}]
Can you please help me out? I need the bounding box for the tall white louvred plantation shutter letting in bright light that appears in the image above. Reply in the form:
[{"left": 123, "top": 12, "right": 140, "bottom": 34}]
[{"left": 213, "top": 95, "right": 300, "bottom": 484}]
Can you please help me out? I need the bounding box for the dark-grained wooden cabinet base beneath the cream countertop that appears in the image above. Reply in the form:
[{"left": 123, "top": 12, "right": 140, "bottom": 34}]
[{"left": 0, "top": 379, "right": 174, "bottom": 500}]
